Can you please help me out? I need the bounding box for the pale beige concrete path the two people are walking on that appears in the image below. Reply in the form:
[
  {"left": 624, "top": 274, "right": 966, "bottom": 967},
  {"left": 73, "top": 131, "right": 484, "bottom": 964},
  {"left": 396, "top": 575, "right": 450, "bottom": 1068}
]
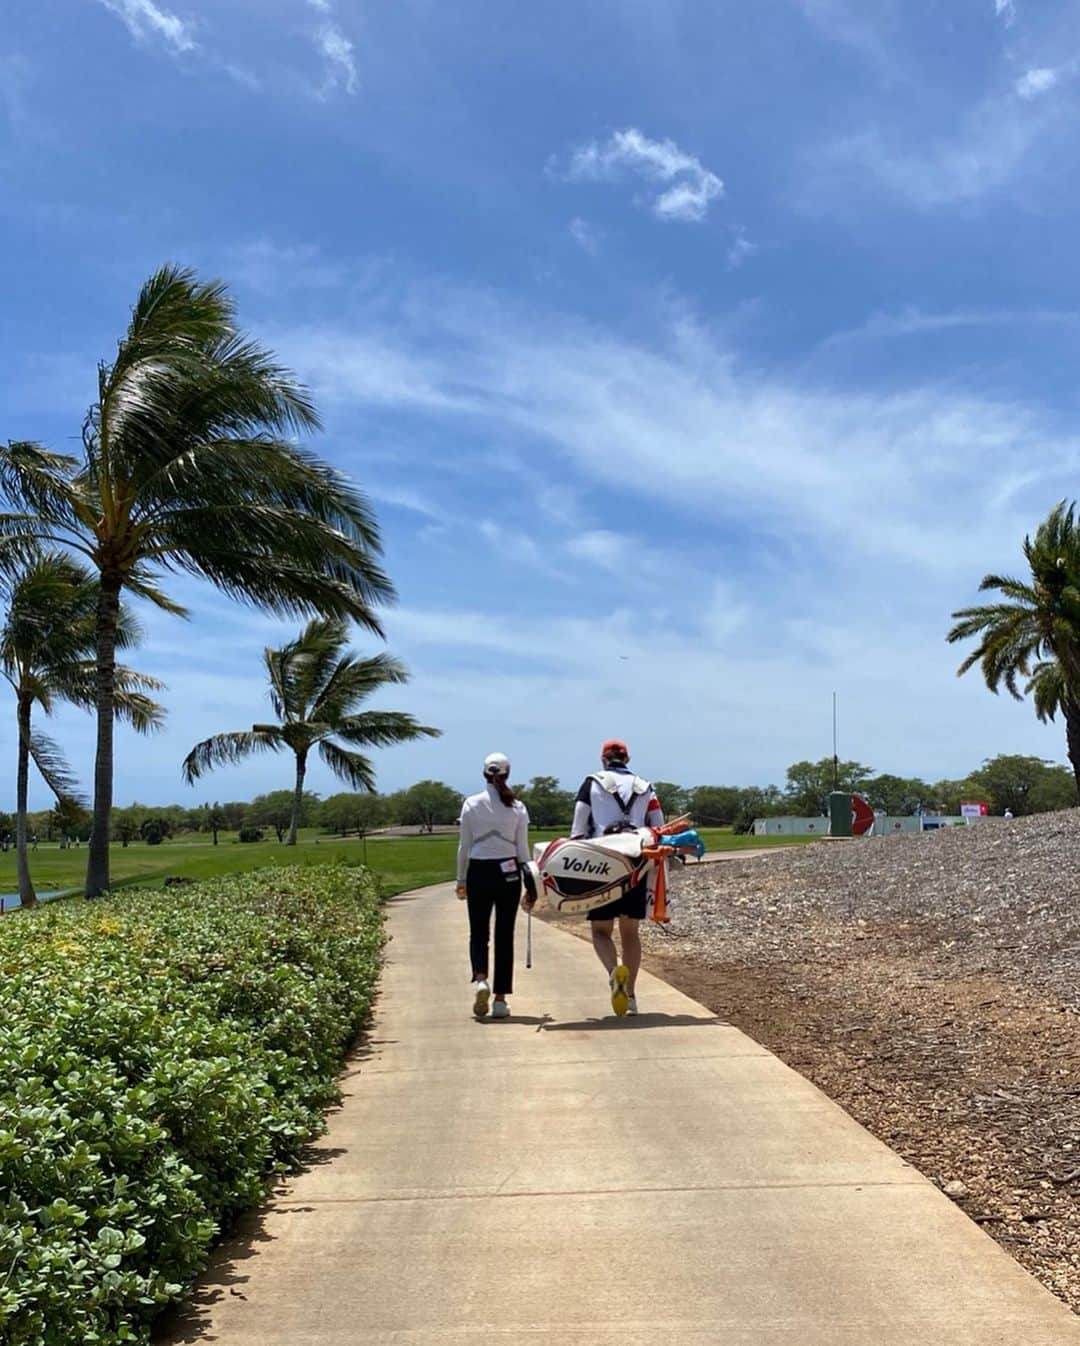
[{"left": 168, "top": 887, "right": 1080, "bottom": 1346}]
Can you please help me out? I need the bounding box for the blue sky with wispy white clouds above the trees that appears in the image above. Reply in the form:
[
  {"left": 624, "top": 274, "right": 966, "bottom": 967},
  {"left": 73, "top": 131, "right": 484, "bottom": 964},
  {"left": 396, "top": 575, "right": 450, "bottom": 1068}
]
[{"left": 0, "top": 0, "right": 1080, "bottom": 805}]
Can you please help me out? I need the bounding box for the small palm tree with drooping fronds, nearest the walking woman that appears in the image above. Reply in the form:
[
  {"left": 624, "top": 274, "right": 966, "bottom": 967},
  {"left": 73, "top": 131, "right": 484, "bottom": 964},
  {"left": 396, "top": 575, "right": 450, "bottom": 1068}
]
[{"left": 183, "top": 618, "right": 440, "bottom": 845}]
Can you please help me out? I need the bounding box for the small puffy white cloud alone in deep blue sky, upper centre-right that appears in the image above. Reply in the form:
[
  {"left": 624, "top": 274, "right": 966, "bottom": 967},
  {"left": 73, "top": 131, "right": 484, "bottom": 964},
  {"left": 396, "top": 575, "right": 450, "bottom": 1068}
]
[{"left": 567, "top": 127, "right": 723, "bottom": 223}]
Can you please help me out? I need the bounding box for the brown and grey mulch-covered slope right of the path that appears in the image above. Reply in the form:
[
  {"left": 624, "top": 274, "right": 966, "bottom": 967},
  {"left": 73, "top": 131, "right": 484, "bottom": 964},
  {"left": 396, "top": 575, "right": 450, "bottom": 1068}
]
[{"left": 635, "top": 810, "right": 1080, "bottom": 1310}]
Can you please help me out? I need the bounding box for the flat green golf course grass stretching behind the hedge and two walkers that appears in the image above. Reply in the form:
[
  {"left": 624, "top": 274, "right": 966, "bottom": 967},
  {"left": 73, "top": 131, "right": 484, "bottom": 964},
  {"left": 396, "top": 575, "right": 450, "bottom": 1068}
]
[{"left": 0, "top": 828, "right": 817, "bottom": 894}]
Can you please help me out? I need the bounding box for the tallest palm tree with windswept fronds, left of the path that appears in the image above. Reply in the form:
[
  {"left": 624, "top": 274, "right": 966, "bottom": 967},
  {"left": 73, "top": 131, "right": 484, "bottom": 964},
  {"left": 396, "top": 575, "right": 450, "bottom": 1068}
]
[{"left": 0, "top": 267, "right": 393, "bottom": 896}]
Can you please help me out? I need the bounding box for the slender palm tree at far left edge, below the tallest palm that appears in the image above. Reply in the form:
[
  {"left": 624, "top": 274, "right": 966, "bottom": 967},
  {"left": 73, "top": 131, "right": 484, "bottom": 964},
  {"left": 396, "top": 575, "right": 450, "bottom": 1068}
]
[{"left": 0, "top": 552, "right": 163, "bottom": 907}]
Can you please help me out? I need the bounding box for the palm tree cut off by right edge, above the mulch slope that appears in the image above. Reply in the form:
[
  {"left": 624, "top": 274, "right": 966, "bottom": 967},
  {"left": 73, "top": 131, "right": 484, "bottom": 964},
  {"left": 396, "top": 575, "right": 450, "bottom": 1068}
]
[{"left": 948, "top": 501, "right": 1080, "bottom": 789}]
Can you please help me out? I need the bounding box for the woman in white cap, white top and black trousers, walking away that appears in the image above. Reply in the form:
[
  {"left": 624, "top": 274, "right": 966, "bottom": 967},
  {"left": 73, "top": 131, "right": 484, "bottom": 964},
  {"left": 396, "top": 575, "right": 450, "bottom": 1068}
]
[{"left": 458, "top": 752, "right": 529, "bottom": 1019}]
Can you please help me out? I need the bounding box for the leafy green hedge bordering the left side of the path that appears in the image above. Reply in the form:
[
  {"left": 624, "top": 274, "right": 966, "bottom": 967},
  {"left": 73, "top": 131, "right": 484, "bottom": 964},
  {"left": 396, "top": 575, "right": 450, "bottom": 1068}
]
[{"left": 0, "top": 867, "right": 382, "bottom": 1346}]
